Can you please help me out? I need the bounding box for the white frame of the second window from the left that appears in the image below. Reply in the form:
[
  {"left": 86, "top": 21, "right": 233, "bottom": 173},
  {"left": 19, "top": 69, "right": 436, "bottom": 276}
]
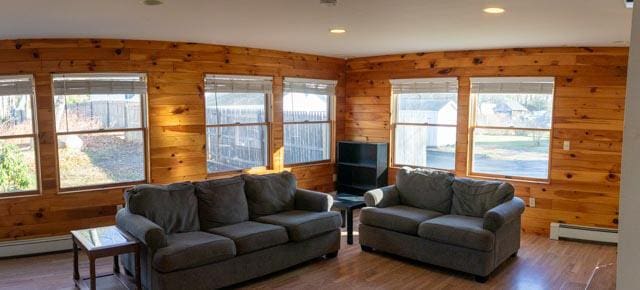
[{"left": 51, "top": 72, "right": 149, "bottom": 193}]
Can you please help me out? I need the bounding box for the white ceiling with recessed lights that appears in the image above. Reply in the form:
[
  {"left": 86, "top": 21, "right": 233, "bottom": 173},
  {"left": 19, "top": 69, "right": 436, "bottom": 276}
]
[{"left": 0, "top": 0, "right": 631, "bottom": 57}]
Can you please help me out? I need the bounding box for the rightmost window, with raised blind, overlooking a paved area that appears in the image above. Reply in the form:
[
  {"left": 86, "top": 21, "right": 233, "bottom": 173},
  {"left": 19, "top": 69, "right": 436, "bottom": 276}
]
[{"left": 470, "top": 77, "right": 554, "bottom": 180}]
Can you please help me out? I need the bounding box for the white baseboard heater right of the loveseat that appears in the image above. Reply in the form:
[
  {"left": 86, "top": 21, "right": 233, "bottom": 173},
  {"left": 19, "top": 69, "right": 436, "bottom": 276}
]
[{"left": 549, "top": 223, "right": 618, "bottom": 244}]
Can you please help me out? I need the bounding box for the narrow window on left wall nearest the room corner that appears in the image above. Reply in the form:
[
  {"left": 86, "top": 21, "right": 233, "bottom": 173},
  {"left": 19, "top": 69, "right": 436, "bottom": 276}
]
[{"left": 282, "top": 78, "right": 337, "bottom": 164}]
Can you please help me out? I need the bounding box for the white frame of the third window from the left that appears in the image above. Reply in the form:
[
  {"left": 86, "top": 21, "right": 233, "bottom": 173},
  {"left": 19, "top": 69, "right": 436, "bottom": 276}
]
[{"left": 204, "top": 74, "right": 273, "bottom": 175}]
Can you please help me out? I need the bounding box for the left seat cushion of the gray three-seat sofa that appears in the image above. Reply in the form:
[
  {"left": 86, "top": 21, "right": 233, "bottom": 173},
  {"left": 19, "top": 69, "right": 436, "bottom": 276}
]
[{"left": 153, "top": 232, "right": 236, "bottom": 273}]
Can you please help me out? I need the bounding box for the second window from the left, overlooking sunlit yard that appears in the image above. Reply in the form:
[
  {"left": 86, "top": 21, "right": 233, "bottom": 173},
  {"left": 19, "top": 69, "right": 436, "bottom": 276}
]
[{"left": 53, "top": 74, "right": 147, "bottom": 190}]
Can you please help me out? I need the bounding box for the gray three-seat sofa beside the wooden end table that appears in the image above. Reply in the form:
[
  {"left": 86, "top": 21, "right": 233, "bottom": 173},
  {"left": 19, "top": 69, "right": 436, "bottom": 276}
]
[{"left": 116, "top": 172, "right": 341, "bottom": 289}]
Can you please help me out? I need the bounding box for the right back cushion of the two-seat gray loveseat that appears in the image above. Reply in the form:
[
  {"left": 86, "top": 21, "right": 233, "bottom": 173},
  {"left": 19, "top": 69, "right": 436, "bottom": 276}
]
[{"left": 451, "top": 178, "right": 515, "bottom": 217}]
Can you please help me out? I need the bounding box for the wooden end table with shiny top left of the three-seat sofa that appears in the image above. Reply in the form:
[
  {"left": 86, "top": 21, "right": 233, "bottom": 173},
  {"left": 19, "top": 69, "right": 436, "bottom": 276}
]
[{"left": 71, "top": 226, "right": 142, "bottom": 290}]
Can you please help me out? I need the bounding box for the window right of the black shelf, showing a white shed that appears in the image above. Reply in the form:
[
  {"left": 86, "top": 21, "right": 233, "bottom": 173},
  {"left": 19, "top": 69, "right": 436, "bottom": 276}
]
[{"left": 391, "top": 78, "right": 458, "bottom": 170}]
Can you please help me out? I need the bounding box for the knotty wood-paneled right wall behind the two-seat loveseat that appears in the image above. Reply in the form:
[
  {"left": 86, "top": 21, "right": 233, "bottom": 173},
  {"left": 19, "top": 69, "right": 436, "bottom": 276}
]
[{"left": 345, "top": 47, "right": 628, "bottom": 234}]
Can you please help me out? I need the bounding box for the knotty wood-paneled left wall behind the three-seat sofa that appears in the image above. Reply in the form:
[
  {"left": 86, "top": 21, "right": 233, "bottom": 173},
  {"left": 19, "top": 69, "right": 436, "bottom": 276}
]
[{"left": 0, "top": 39, "right": 345, "bottom": 240}]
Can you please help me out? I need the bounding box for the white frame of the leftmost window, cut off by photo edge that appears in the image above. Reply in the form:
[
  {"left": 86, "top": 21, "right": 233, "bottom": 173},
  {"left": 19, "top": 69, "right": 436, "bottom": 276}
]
[{"left": 0, "top": 75, "right": 41, "bottom": 198}]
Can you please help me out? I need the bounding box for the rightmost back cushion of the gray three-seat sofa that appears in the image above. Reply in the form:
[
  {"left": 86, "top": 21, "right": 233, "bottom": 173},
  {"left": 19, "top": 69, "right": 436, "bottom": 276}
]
[{"left": 242, "top": 171, "right": 297, "bottom": 219}]
